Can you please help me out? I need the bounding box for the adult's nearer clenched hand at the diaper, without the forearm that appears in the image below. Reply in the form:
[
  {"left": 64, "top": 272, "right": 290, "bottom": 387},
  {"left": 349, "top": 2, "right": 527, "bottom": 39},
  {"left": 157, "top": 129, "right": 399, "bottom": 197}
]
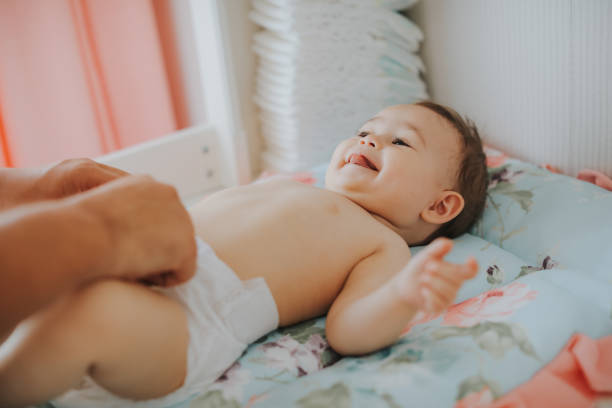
[{"left": 74, "top": 176, "right": 196, "bottom": 286}]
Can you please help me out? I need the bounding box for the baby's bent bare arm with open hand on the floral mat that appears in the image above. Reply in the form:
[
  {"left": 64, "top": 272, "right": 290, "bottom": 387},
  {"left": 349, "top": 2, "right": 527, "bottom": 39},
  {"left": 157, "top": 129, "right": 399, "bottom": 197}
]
[{"left": 326, "top": 239, "right": 478, "bottom": 355}]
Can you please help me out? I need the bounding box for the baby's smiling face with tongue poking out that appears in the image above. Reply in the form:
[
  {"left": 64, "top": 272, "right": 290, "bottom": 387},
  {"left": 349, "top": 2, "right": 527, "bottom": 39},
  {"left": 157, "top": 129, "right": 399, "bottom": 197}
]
[{"left": 325, "top": 105, "right": 460, "bottom": 233}]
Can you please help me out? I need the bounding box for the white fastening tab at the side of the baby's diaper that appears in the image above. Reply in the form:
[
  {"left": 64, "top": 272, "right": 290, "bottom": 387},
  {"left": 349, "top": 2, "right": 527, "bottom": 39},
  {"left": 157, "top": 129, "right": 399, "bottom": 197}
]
[{"left": 219, "top": 278, "right": 278, "bottom": 344}]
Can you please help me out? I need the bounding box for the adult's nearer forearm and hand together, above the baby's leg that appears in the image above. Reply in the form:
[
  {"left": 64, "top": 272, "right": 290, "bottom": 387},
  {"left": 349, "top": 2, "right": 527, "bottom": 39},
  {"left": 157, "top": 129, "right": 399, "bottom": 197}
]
[{"left": 0, "top": 171, "right": 196, "bottom": 338}]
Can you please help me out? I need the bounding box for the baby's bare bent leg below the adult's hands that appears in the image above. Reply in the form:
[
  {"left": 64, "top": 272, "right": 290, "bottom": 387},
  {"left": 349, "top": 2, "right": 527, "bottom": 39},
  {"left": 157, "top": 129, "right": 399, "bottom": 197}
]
[{"left": 0, "top": 281, "right": 189, "bottom": 407}]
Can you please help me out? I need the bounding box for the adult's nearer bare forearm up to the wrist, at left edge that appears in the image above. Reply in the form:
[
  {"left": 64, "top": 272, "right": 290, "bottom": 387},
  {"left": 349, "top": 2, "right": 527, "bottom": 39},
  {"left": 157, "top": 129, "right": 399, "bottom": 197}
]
[{"left": 0, "top": 199, "right": 111, "bottom": 335}]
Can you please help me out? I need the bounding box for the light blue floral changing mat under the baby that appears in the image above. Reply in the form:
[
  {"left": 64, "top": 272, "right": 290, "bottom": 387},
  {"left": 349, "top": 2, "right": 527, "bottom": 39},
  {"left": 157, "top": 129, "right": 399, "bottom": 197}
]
[{"left": 43, "top": 149, "right": 612, "bottom": 408}]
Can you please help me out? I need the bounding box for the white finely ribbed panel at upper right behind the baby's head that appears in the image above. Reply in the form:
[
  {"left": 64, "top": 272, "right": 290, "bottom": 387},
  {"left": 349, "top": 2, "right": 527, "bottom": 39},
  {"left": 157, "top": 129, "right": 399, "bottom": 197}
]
[{"left": 410, "top": 0, "right": 612, "bottom": 175}]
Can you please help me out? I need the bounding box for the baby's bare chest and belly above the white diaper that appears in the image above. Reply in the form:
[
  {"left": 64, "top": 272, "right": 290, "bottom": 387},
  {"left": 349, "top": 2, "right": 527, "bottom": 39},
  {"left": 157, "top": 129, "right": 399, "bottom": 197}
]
[{"left": 190, "top": 182, "right": 388, "bottom": 325}]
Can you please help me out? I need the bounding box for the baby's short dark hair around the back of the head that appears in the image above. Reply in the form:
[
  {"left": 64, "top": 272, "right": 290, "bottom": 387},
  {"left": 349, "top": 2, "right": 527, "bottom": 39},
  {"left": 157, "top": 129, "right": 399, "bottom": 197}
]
[{"left": 415, "top": 101, "right": 489, "bottom": 245}]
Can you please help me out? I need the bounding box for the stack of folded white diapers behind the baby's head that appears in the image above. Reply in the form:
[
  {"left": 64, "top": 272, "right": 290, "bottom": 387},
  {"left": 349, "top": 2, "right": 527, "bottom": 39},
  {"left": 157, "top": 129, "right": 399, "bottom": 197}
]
[{"left": 250, "top": 0, "right": 428, "bottom": 171}]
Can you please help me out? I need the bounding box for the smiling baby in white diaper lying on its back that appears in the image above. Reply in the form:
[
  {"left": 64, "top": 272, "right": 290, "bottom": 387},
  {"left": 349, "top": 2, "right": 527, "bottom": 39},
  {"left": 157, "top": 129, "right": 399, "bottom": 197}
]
[{"left": 0, "top": 102, "right": 487, "bottom": 408}]
